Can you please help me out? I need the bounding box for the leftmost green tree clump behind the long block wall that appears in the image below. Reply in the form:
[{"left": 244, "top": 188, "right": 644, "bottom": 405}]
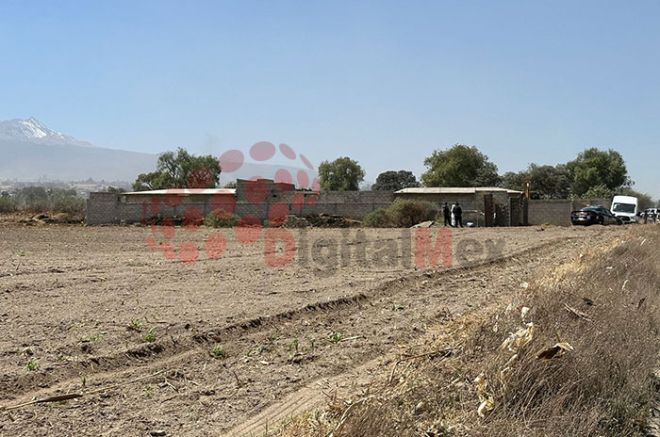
[{"left": 133, "top": 148, "right": 221, "bottom": 191}]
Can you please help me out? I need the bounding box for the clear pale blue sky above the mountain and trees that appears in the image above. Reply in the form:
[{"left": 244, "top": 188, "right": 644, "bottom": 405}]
[{"left": 0, "top": 0, "right": 660, "bottom": 198}]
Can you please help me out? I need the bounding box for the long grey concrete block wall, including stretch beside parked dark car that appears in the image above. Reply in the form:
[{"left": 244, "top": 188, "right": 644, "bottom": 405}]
[{"left": 87, "top": 187, "right": 610, "bottom": 226}]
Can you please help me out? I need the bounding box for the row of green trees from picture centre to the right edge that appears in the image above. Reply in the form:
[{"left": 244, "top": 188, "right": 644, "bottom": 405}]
[{"left": 319, "top": 144, "right": 653, "bottom": 207}]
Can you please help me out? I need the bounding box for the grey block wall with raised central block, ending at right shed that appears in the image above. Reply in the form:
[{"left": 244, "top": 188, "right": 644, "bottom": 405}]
[{"left": 87, "top": 179, "right": 509, "bottom": 226}]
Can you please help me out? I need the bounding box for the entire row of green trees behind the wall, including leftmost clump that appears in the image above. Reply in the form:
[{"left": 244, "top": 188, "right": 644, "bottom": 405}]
[{"left": 133, "top": 144, "right": 652, "bottom": 205}]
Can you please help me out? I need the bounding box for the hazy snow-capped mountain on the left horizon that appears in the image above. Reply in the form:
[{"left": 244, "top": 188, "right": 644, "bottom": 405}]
[{"left": 0, "top": 118, "right": 158, "bottom": 182}]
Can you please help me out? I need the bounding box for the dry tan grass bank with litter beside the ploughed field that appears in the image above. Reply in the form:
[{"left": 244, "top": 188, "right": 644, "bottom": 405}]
[{"left": 281, "top": 227, "right": 660, "bottom": 437}]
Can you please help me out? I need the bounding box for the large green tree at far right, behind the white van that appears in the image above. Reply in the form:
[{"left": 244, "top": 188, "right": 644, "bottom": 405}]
[{"left": 566, "top": 147, "right": 630, "bottom": 196}]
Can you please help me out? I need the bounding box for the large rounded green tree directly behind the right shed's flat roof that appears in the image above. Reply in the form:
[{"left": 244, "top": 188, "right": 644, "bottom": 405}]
[{"left": 422, "top": 144, "right": 499, "bottom": 187}]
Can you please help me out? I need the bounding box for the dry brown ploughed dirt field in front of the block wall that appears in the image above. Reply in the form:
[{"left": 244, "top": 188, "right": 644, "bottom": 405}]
[{"left": 0, "top": 223, "right": 628, "bottom": 436}]
